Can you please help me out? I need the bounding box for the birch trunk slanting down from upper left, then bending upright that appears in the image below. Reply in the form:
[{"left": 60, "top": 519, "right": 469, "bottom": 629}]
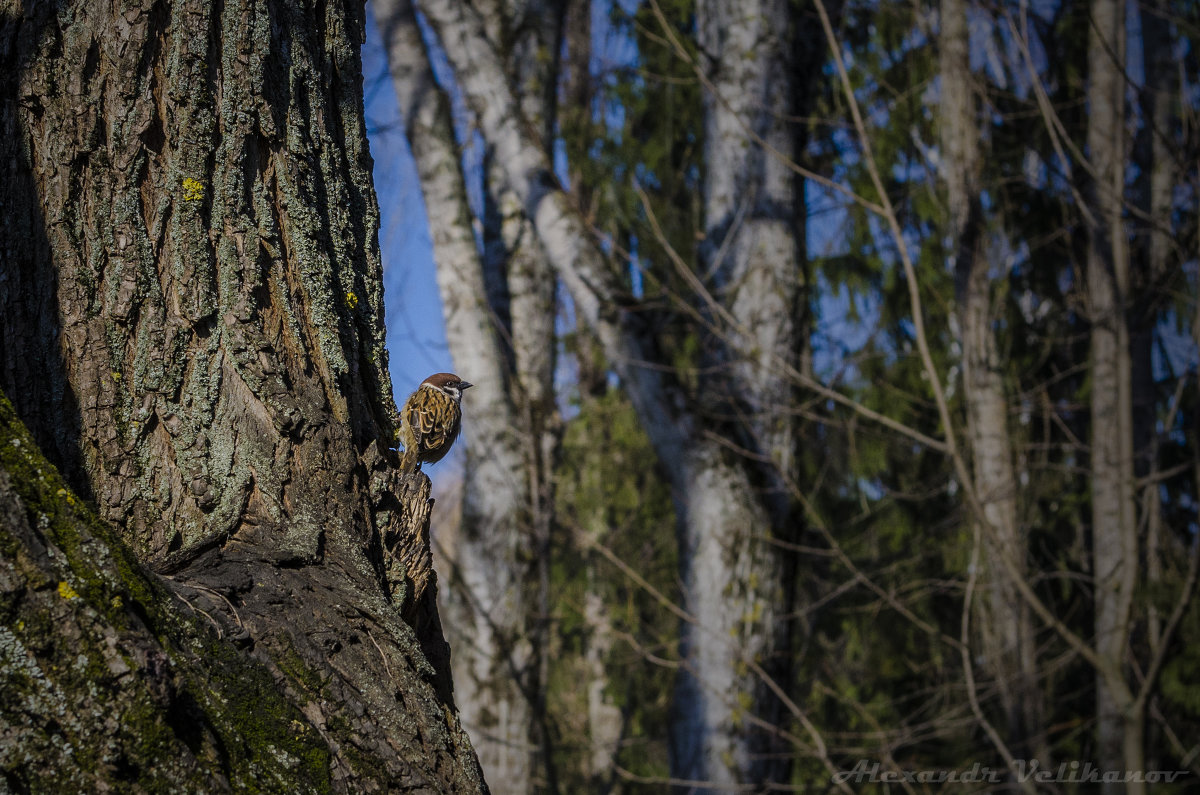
[{"left": 421, "top": 0, "right": 779, "bottom": 789}]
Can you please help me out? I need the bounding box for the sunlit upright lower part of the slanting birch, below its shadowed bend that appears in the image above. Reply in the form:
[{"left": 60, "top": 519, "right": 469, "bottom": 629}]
[{"left": 671, "top": 442, "right": 782, "bottom": 790}]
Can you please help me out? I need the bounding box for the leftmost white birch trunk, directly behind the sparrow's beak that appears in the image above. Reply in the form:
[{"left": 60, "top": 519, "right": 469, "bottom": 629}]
[{"left": 374, "top": 0, "right": 533, "bottom": 794}]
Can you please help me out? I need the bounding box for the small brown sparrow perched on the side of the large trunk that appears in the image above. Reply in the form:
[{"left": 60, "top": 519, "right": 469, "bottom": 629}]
[{"left": 400, "top": 372, "right": 473, "bottom": 474}]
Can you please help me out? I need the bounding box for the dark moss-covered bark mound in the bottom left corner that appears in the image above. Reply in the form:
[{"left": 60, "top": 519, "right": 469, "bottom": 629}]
[{"left": 0, "top": 395, "right": 334, "bottom": 793}]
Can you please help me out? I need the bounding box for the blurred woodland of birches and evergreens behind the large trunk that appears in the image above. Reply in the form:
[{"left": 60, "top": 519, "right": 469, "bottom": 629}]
[{"left": 364, "top": 0, "right": 1200, "bottom": 793}]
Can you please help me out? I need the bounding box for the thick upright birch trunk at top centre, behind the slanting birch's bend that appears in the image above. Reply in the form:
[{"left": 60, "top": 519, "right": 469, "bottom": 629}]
[{"left": 696, "top": 0, "right": 802, "bottom": 485}]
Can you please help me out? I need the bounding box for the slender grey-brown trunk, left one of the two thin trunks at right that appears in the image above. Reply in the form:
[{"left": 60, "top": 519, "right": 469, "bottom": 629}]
[{"left": 938, "top": 0, "right": 1046, "bottom": 761}]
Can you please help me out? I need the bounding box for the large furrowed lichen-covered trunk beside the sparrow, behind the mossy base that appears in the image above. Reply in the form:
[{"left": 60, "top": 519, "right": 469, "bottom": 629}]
[{"left": 0, "top": 0, "right": 484, "bottom": 791}]
